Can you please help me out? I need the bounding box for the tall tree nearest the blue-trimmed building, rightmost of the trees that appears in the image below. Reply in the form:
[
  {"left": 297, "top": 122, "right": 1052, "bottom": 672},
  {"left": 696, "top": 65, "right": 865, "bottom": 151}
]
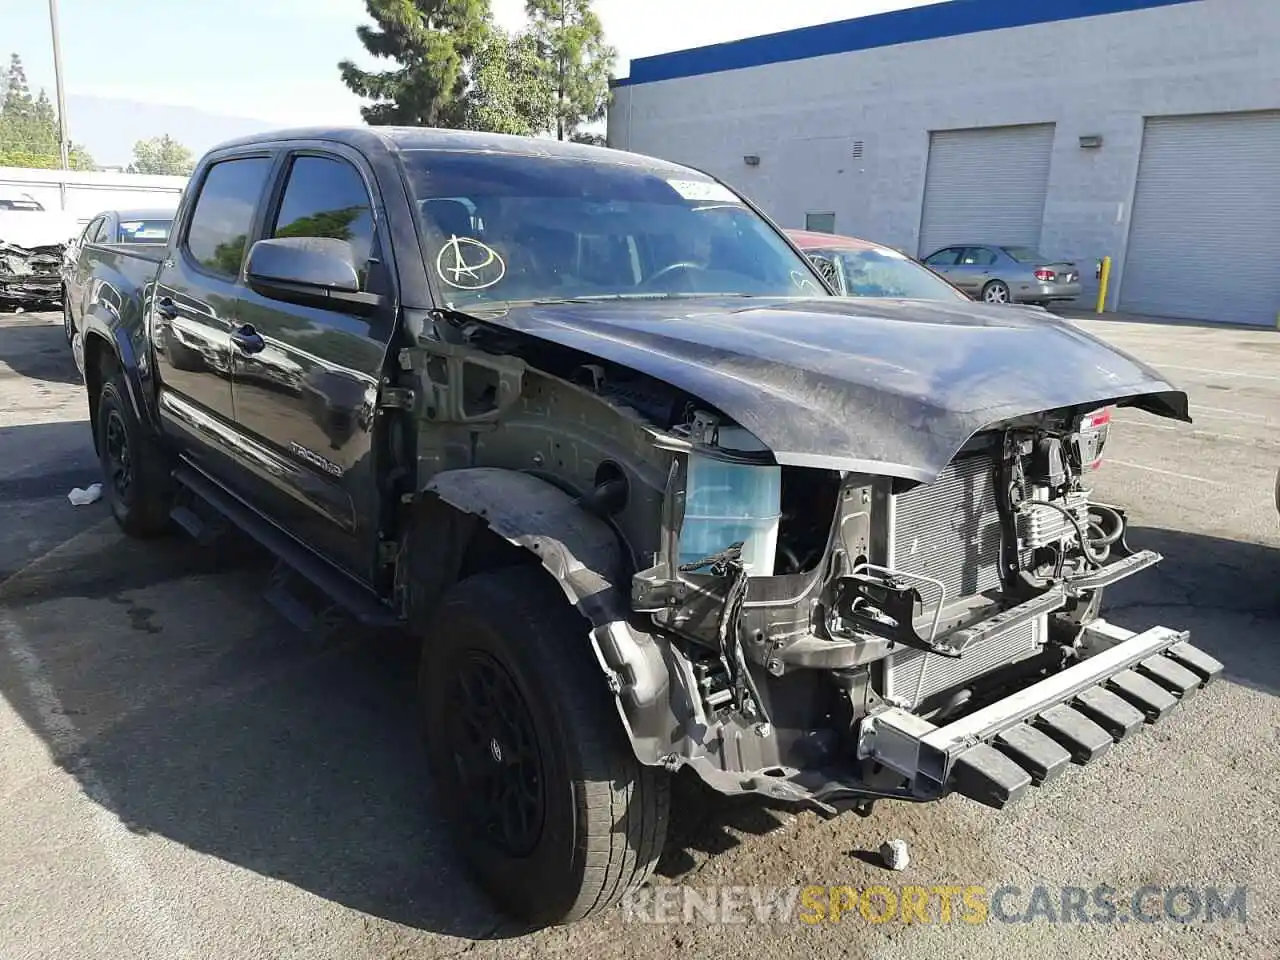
[{"left": 525, "top": 0, "right": 617, "bottom": 140}]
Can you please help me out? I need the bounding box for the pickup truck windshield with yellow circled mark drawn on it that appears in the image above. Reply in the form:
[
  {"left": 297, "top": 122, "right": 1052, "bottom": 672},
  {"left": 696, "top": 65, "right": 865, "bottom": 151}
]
[{"left": 403, "top": 150, "right": 831, "bottom": 307}]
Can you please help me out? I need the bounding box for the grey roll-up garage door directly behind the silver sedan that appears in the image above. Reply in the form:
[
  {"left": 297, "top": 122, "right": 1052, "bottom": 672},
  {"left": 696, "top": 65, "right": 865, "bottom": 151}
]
[{"left": 919, "top": 123, "right": 1053, "bottom": 257}]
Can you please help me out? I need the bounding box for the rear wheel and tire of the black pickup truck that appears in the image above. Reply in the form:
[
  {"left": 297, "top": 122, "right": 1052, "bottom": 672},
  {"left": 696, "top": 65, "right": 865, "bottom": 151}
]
[{"left": 97, "top": 367, "right": 173, "bottom": 539}]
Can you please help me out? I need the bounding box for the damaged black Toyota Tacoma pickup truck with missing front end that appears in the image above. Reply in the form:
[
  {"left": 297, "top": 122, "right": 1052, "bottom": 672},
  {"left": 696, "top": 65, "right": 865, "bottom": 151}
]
[{"left": 76, "top": 128, "right": 1222, "bottom": 923}]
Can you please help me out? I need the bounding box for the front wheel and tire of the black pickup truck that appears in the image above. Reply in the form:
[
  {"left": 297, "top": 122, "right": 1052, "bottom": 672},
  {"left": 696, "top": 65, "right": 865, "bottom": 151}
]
[{"left": 419, "top": 566, "right": 671, "bottom": 927}]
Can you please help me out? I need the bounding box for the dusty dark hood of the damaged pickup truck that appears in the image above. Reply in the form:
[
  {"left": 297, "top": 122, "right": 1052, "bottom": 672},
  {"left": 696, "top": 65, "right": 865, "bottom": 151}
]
[{"left": 470, "top": 297, "right": 1190, "bottom": 483}]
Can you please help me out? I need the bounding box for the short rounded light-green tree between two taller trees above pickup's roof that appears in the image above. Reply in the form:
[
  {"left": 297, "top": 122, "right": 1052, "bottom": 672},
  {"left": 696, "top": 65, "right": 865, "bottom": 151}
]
[{"left": 462, "top": 27, "right": 556, "bottom": 137}]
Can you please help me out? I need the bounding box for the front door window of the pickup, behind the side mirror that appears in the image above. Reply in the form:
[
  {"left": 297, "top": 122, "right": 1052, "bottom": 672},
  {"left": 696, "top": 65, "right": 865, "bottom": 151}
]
[{"left": 270, "top": 156, "right": 375, "bottom": 289}]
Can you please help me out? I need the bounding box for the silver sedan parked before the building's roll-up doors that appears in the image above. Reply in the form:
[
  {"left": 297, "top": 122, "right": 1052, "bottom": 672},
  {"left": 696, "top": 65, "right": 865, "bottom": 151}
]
[{"left": 924, "top": 243, "right": 1080, "bottom": 306}]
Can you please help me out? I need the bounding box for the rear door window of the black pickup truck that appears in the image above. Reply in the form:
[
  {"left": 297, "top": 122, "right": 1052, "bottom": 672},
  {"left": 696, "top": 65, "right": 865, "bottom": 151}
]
[{"left": 187, "top": 156, "right": 271, "bottom": 278}]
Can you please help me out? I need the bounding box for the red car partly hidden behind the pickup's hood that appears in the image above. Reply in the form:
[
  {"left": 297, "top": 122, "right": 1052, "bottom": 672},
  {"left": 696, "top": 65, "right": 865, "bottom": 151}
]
[{"left": 786, "top": 230, "right": 969, "bottom": 301}]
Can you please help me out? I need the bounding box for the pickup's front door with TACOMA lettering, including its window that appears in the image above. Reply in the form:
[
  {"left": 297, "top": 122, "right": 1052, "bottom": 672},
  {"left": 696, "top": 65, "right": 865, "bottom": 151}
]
[{"left": 234, "top": 145, "right": 396, "bottom": 579}]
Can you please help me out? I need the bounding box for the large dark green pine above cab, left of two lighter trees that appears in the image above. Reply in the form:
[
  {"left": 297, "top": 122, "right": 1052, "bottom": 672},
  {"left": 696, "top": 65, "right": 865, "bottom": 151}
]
[{"left": 338, "top": 0, "right": 490, "bottom": 127}]
